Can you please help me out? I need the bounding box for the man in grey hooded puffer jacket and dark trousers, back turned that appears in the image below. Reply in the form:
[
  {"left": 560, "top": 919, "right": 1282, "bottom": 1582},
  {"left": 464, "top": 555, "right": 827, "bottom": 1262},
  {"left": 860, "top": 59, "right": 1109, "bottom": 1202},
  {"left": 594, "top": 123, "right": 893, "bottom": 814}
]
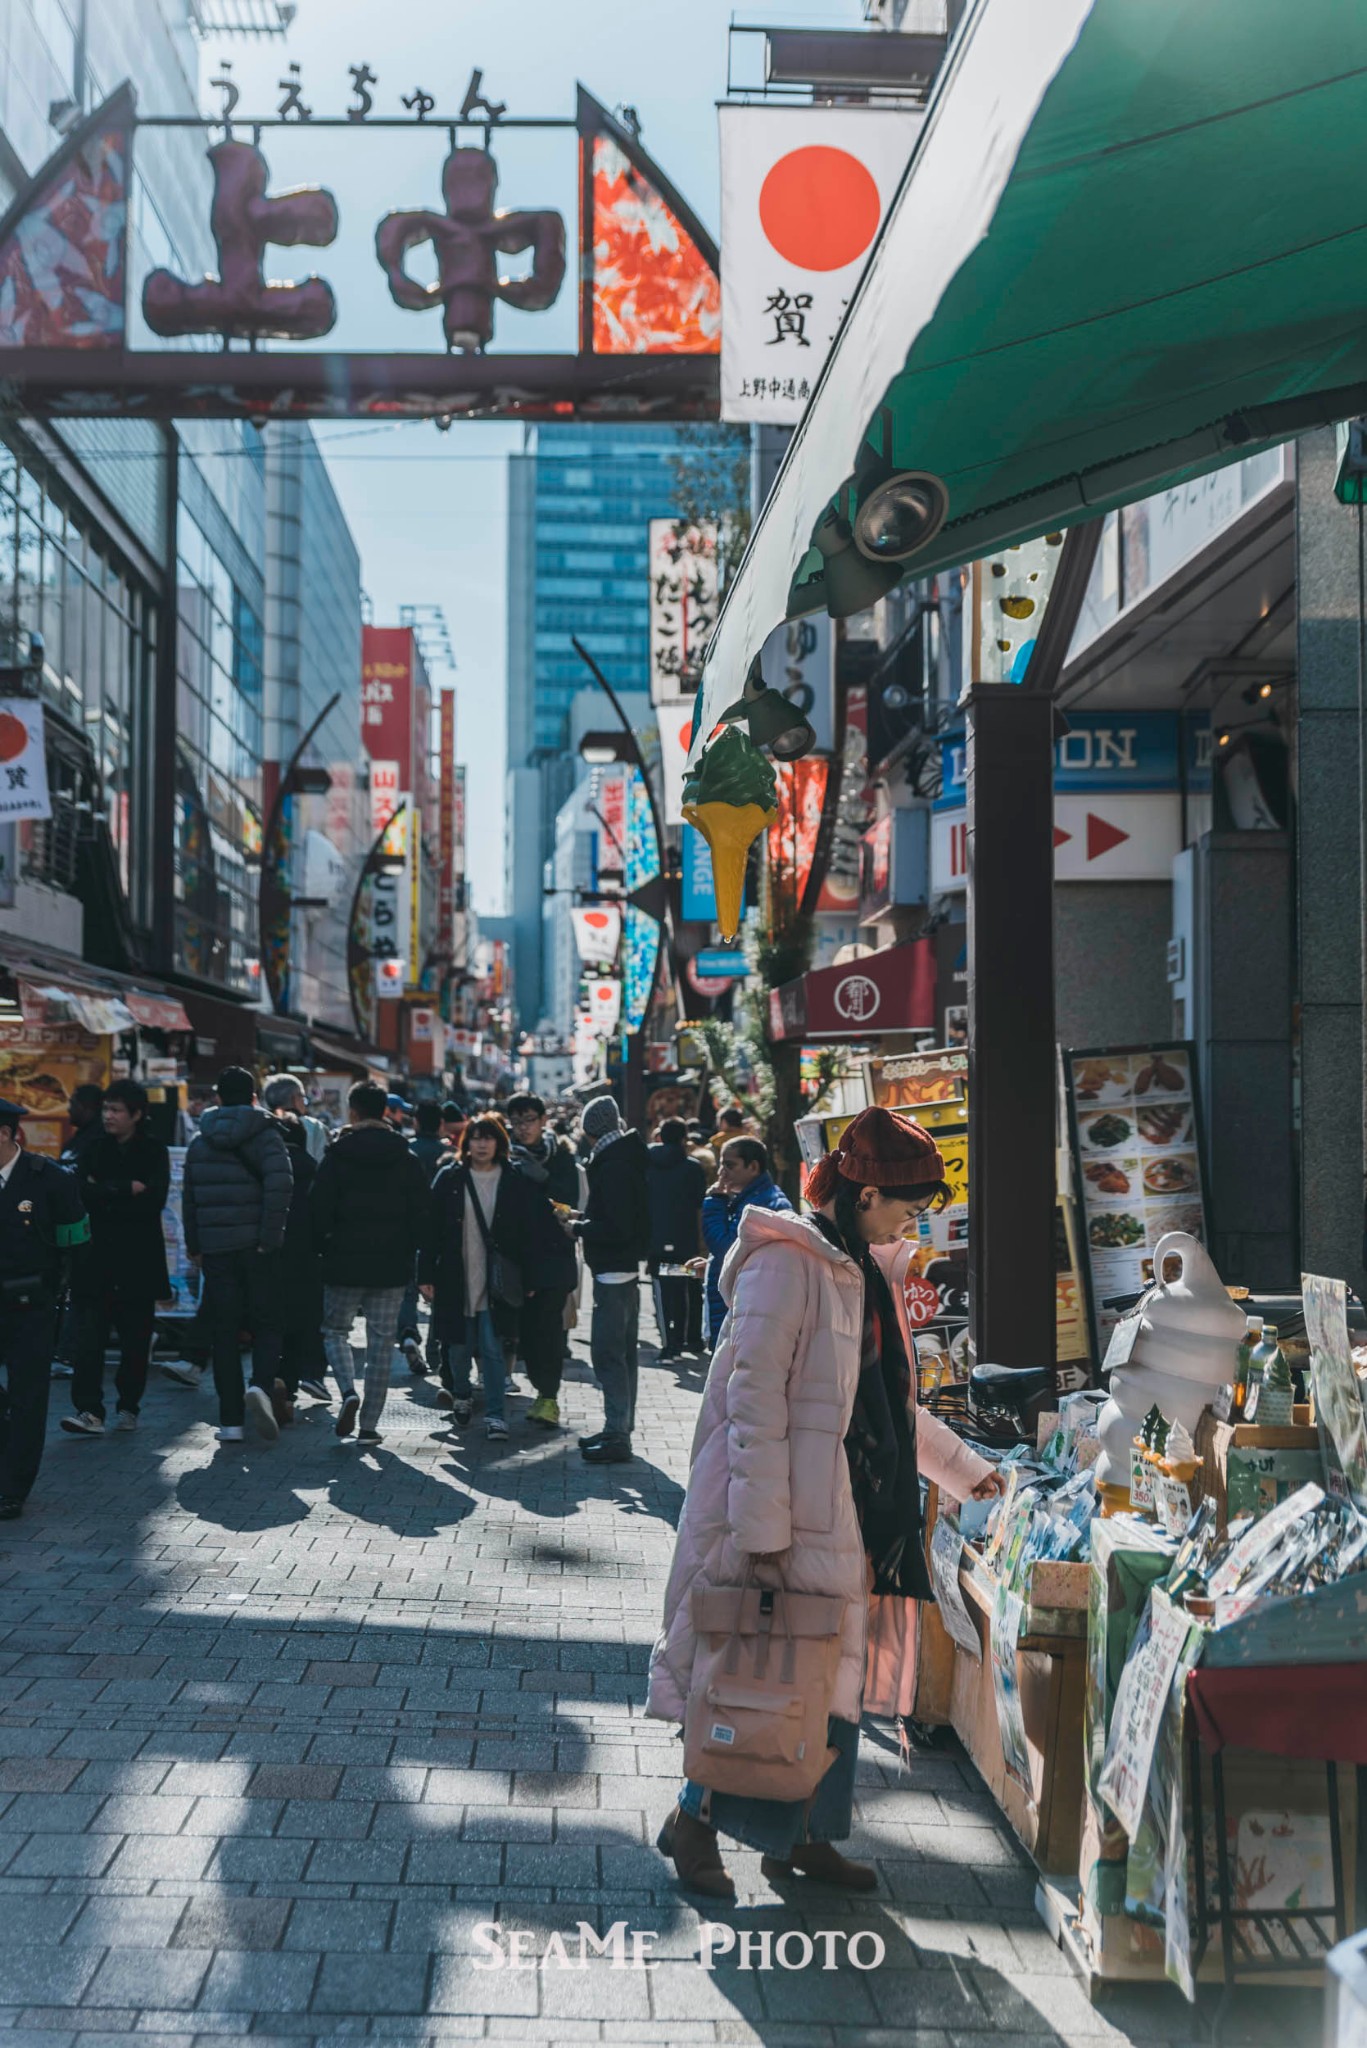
[{"left": 180, "top": 1067, "right": 295, "bottom": 1444}]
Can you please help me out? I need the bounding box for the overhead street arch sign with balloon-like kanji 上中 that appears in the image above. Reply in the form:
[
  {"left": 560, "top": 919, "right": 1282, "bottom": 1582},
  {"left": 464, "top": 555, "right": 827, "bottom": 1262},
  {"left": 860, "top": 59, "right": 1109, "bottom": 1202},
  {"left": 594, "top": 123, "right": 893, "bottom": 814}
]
[{"left": 0, "top": 78, "right": 721, "bottom": 420}]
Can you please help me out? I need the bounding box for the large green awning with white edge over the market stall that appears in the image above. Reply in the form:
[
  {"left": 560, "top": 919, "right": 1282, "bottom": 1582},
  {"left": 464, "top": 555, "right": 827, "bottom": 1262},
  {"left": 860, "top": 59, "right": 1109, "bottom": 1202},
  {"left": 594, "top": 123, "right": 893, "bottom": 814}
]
[{"left": 699, "top": 0, "right": 1367, "bottom": 749}]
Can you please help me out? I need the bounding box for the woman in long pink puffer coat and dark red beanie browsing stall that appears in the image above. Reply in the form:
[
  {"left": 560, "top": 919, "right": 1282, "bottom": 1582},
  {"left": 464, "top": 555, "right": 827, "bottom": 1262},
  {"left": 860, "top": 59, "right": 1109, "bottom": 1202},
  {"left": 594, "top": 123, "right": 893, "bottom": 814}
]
[{"left": 648, "top": 1110, "right": 1000, "bottom": 1898}]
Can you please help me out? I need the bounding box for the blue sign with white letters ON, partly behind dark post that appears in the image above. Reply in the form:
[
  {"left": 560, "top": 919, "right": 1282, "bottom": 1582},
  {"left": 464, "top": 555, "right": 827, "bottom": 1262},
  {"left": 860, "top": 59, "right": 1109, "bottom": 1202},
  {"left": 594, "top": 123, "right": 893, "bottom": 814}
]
[{"left": 935, "top": 711, "right": 1213, "bottom": 811}]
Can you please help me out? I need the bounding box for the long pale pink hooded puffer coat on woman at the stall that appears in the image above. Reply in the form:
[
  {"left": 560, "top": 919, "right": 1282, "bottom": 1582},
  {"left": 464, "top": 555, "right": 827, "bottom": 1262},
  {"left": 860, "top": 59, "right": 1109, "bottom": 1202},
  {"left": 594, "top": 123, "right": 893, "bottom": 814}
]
[{"left": 646, "top": 1208, "right": 990, "bottom": 1720}]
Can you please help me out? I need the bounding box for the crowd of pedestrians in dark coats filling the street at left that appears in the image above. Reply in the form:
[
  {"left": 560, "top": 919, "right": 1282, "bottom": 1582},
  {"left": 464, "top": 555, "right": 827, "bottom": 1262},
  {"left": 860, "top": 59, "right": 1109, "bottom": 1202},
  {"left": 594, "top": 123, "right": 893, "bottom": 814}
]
[{"left": 0, "top": 1067, "right": 778, "bottom": 1520}]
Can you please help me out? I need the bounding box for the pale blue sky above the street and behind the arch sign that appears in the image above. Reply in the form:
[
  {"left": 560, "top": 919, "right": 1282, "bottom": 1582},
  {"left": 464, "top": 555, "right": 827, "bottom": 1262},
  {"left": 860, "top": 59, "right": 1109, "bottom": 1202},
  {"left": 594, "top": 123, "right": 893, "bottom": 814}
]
[{"left": 197, "top": 0, "right": 861, "bottom": 913}]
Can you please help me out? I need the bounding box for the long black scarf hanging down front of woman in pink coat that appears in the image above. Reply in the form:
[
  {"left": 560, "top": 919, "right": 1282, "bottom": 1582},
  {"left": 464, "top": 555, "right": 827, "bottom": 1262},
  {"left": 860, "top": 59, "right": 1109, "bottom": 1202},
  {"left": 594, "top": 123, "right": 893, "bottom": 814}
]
[{"left": 814, "top": 1214, "right": 935, "bottom": 1599}]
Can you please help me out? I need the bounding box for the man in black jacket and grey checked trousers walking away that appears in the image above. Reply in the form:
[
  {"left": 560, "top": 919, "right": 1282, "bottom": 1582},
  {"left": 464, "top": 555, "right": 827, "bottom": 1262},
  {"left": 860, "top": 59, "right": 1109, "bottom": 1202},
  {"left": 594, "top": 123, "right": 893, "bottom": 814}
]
[{"left": 312, "top": 1081, "right": 430, "bottom": 1444}]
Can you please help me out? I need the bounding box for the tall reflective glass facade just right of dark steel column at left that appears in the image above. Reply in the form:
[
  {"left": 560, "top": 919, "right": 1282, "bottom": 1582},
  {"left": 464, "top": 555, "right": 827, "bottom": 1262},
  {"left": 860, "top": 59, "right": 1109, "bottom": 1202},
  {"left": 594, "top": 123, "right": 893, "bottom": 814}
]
[{"left": 176, "top": 508, "right": 262, "bottom": 993}]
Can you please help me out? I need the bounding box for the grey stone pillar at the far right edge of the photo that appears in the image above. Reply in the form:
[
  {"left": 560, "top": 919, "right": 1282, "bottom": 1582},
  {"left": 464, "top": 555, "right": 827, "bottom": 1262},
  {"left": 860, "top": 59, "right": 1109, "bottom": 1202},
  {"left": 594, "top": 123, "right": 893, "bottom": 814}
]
[{"left": 1295, "top": 428, "right": 1367, "bottom": 1292}]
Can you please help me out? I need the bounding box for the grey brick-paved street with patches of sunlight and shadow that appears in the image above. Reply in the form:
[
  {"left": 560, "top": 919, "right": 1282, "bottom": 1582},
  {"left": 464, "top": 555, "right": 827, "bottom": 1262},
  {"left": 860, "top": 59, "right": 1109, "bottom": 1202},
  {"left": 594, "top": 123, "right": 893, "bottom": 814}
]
[{"left": 0, "top": 1310, "right": 1314, "bottom": 2048}]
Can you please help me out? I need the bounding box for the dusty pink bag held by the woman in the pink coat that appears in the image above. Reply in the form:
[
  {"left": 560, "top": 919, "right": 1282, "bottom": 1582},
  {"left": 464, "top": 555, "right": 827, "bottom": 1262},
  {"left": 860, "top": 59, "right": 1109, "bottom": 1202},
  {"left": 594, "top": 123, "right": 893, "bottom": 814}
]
[{"left": 685, "top": 1573, "right": 844, "bottom": 1800}]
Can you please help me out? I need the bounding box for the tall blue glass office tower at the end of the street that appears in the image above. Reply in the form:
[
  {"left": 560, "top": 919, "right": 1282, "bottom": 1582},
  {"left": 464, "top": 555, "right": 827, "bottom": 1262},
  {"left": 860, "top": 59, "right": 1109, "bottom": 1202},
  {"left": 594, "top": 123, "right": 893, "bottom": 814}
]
[{"left": 508, "top": 424, "right": 746, "bottom": 1030}]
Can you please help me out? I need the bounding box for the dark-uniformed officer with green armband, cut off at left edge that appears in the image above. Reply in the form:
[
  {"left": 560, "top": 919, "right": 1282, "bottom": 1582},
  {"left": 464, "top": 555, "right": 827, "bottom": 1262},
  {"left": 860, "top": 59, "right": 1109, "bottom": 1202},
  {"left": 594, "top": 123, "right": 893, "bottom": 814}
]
[{"left": 0, "top": 1100, "right": 90, "bottom": 1522}]
